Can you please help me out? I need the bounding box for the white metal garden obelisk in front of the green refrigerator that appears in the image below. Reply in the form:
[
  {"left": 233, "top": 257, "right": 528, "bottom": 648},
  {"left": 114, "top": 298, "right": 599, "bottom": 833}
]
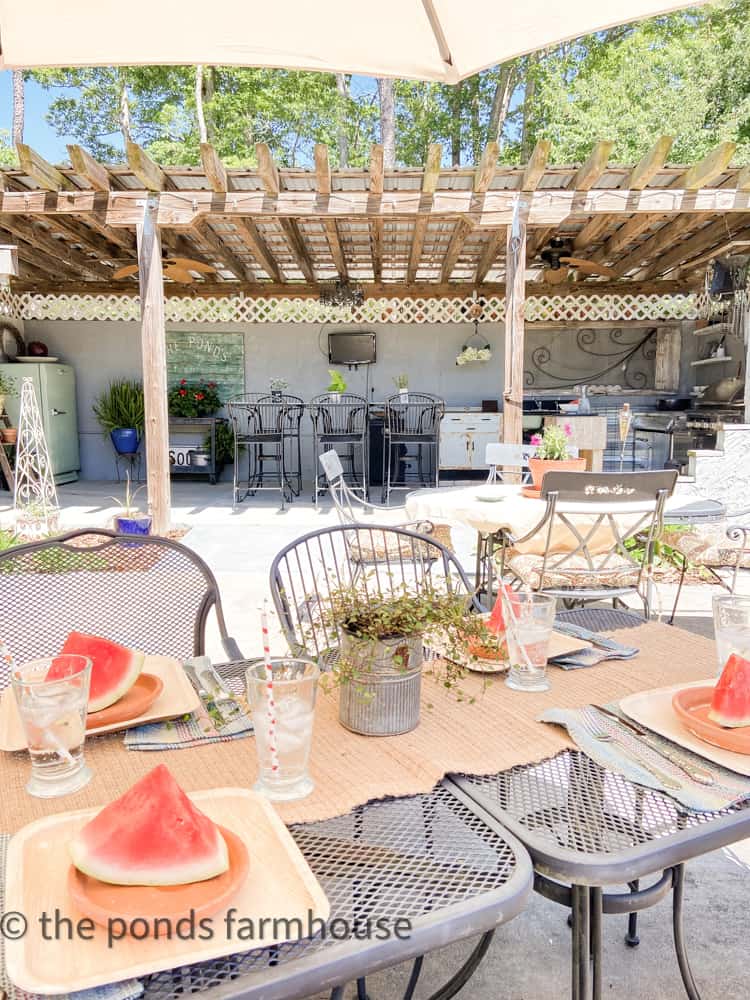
[{"left": 13, "top": 378, "right": 60, "bottom": 541}]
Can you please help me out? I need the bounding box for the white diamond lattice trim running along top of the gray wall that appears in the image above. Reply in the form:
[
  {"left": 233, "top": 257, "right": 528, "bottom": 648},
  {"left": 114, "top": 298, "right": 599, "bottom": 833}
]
[{"left": 8, "top": 290, "right": 705, "bottom": 323}]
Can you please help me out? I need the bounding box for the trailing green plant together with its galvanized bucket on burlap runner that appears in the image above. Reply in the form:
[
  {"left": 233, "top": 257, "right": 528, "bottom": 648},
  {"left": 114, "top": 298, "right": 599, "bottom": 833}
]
[{"left": 315, "top": 585, "right": 478, "bottom": 736}]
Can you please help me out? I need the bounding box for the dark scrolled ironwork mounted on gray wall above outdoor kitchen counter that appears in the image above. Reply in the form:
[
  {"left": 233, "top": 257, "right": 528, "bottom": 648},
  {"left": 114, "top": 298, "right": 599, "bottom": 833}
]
[{"left": 523, "top": 327, "right": 656, "bottom": 389}]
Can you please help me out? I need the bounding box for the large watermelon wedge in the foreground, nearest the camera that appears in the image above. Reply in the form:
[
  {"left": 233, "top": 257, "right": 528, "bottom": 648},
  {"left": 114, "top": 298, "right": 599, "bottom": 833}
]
[{"left": 70, "top": 764, "right": 229, "bottom": 886}]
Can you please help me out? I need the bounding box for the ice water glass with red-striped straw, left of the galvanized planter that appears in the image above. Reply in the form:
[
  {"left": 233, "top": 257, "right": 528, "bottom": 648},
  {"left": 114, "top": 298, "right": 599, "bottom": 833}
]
[{"left": 245, "top": 657, "right": 320, "bottom": 801}]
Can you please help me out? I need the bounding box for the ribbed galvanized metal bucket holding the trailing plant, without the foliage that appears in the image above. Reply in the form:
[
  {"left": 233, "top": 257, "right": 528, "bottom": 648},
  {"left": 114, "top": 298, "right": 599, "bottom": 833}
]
[{"left": 339, "top": 635, "right": 423, "bottom": 736}]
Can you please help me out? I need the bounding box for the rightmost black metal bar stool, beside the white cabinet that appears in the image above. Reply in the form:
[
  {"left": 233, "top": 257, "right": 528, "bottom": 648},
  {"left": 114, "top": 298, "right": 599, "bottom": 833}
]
[{"left": 383, "top": 392, "right": 445, "bottom": 503}]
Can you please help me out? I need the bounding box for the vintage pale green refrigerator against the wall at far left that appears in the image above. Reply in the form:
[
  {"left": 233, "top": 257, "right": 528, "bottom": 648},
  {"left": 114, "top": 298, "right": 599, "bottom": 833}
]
[{"left": 0, "top": 361, "right": 81, "bottom": 484}]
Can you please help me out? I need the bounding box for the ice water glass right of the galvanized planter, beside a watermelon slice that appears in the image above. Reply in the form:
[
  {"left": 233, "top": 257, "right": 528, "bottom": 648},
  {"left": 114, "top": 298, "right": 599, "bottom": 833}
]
[{"left": 505, "top": 593, "right": 556, "bottom": 691}]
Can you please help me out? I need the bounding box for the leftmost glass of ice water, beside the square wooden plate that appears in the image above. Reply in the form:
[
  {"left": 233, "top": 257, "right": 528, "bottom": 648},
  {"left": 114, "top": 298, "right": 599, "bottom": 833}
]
[{"left": 11, "top": 653, "right": 91, "bottom": 799}]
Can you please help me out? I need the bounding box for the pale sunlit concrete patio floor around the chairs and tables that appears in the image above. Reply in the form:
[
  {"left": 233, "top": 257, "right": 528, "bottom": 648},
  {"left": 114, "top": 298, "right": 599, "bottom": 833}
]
[{"left": 0, "top": 482, "right": 750, "bottom": 1000}]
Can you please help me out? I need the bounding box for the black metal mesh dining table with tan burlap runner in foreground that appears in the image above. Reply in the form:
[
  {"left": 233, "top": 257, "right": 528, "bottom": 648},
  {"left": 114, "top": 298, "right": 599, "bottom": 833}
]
[{"left": 0, "top": 612, "right": 750, "bottom": 1000}]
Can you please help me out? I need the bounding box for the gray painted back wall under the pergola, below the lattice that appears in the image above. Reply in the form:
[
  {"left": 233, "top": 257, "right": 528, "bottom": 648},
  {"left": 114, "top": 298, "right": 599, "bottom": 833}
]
[{"left": 25, "top": 320, "right": 694, "bottom": 479}]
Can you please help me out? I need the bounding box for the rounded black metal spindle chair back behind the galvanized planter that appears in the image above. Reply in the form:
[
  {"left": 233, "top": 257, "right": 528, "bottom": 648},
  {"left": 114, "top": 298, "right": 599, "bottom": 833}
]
[{"left": 270, "top": 525, "right": 472, "bottom": 659}]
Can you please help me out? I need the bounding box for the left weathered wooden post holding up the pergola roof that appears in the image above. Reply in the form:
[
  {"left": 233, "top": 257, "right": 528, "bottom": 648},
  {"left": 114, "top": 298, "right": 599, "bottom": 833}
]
[{"left": 136, "top": 195, "right": 171, "bottom": 535}]
